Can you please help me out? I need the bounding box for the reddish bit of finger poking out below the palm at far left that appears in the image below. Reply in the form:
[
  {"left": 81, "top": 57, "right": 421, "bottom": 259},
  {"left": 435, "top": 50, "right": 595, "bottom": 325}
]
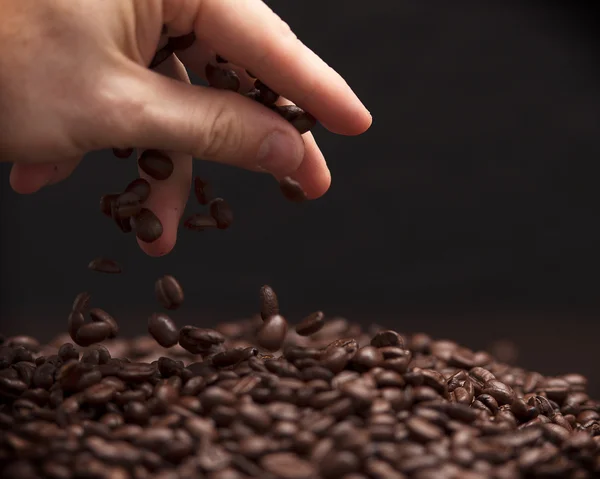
[{"left": 10, "top": 159, "right": 80, "bottom": 195}]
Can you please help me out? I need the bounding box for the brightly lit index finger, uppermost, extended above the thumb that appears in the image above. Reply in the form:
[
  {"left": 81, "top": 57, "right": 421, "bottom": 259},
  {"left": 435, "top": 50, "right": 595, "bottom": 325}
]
[{"left": 194, "top": 0, "right": 372, "bottom": 135}]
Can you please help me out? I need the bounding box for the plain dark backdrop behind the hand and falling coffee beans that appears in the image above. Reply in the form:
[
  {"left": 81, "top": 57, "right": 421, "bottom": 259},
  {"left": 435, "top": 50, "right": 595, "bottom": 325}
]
[{"left": 0, "top": 0, "right": 600, "bottom": 396}]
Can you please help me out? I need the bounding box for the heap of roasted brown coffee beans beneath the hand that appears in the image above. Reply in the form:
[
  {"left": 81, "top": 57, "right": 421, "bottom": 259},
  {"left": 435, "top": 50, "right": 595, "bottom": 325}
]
[{"left": 0, "top": 284, "right": 600, "bottom": 479}]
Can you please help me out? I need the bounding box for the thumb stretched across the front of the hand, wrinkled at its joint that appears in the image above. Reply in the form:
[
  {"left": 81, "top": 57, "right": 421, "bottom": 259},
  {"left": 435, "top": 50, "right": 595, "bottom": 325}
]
[{"left": 116, "top": 64, "right": 304, "bottom": 178}]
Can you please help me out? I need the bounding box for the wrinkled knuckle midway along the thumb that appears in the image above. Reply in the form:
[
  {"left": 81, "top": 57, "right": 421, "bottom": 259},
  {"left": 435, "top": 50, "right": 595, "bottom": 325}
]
[{"left": 201, "top": 101, "right": 244, "bottom": 159}]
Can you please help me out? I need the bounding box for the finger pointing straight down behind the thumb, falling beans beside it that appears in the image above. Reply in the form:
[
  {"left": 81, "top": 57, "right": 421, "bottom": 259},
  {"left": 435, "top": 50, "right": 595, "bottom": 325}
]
[{"left": 138, "top": 56, "right": 192, "bottom": 256}]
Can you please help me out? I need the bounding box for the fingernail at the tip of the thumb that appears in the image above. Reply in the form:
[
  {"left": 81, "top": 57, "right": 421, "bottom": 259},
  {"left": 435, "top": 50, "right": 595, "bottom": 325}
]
[{"left": 257, "top": 131, "right": 304, "bottom": 176}]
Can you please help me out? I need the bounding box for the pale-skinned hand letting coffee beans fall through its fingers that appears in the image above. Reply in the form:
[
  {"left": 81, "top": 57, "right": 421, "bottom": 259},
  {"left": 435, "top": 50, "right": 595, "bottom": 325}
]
[{"left": 0, "top": 0, "right": 372, "bottom": 256}]
